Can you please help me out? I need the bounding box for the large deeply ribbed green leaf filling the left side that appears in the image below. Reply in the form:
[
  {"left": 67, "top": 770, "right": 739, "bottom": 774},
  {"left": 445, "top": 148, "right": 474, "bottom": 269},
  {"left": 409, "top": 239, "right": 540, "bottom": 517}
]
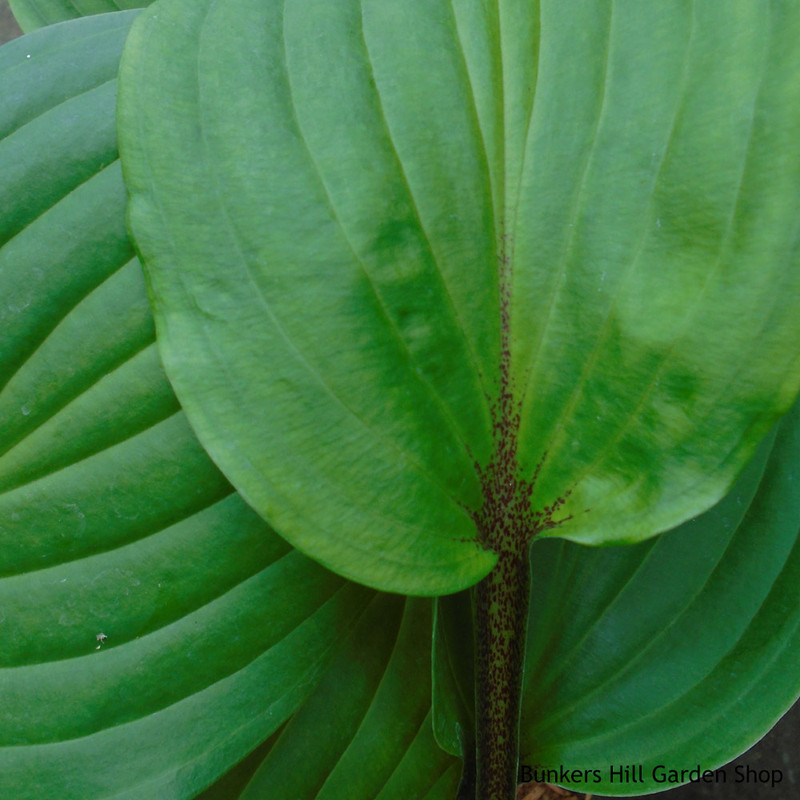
[{"left": 0, "top": 13, "right": 386, "bottom": 800}]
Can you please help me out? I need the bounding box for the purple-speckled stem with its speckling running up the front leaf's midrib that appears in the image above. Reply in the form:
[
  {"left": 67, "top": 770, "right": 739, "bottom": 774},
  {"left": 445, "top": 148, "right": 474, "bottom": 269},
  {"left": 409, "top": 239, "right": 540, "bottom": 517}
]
[{"left": 473, "top": 227, "right": 569, "bottom": 800}]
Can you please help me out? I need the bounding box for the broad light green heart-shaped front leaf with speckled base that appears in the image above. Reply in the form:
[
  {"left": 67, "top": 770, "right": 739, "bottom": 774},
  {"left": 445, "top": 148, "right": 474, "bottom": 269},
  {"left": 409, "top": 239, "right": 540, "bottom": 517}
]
[{"left": 120, "top": 0, "right": 800, "bottom": 594}]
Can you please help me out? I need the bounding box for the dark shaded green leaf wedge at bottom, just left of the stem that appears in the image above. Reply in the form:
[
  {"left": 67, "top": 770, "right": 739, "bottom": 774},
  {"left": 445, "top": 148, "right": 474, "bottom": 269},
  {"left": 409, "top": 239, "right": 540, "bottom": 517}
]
[{"left": 206, "top": 595, "right": 460, "bottom": 800}]
